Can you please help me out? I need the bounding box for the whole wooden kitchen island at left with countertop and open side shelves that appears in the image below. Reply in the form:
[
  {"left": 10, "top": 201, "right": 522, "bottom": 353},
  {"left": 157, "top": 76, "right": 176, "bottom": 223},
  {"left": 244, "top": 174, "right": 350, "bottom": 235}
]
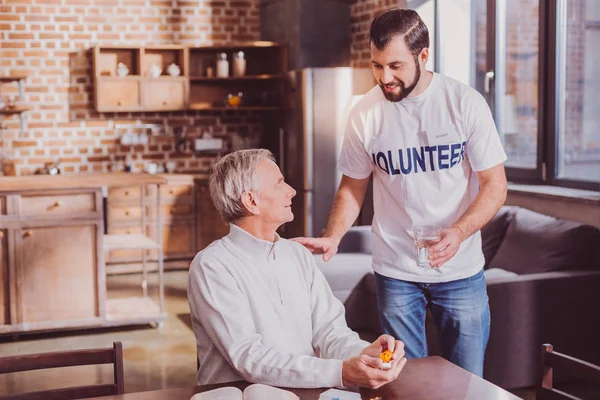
[{"left": 0, "top": 174, "right": 175, "bottom": 334}]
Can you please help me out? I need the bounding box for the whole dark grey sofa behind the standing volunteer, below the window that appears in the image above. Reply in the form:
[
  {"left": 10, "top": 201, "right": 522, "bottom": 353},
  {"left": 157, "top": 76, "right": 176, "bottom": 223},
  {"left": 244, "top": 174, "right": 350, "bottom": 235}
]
[{"left": 315, "top": 206, "right": 600, "bottom": 389}]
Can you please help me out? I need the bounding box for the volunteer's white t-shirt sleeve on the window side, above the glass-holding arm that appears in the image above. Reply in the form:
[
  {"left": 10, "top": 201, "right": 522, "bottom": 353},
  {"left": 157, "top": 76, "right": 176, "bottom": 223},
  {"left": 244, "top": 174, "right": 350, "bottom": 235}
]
[{"left": 466, "top": 93, "right": 507, "bottom": 172}]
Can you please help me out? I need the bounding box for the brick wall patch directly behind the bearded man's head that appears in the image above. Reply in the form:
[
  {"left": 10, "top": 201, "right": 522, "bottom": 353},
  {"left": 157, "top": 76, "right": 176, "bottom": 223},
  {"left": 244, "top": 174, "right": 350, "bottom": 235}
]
[{"left": 350, "top": 0, "right": 406, "bottom": 68}]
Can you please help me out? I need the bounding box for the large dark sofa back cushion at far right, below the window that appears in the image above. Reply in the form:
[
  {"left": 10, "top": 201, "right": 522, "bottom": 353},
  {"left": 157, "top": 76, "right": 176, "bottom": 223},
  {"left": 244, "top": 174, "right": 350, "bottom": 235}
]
[{"left": 490, "top": 208, "right": 600, "bottom": 275}]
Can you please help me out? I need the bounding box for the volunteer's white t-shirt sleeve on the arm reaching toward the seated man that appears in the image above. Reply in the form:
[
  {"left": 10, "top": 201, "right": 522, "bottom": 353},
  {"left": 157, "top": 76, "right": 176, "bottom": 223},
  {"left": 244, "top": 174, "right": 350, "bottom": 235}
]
[{"left": 339, "top": 107, "right": 373, "bottom": 179}]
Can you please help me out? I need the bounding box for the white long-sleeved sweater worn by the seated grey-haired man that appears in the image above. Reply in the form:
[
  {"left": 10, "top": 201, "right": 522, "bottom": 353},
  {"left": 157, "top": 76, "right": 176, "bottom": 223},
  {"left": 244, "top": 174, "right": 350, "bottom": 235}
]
[{"left": 188, "top": 224, "right": 370, "bottom": 388}]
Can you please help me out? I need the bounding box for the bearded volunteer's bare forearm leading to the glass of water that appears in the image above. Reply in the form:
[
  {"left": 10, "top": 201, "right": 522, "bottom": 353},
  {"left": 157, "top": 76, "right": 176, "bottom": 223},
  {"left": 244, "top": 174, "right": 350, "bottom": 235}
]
[{"left": 452, "top": 182, "right": 506, "bottom": 240}]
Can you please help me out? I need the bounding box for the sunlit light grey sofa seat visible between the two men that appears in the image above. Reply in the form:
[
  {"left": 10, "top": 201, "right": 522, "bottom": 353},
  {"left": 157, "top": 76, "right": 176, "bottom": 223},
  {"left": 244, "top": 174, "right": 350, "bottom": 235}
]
[{"left": 314, "top": 253, "right": 373, "bottom": 303}]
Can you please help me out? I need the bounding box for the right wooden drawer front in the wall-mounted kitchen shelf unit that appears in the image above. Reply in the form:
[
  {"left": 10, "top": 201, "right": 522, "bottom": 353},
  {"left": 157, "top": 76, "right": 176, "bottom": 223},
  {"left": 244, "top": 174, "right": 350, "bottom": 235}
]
[{"left": 145, "top": 78, "right": 187, "bottom": 110}]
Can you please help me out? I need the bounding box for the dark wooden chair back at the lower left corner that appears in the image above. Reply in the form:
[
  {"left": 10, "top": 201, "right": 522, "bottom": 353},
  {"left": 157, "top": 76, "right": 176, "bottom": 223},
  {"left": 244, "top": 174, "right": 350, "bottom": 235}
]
[{"left": 0, "top": 342, "right": 125, "bottom": 400}]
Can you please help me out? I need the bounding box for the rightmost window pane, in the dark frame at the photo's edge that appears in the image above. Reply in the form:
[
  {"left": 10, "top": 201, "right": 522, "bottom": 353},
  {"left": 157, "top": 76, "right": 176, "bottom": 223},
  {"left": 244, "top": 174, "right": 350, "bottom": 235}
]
[{"left": 556, "top": 0, "right": 600, "bottom": 182}]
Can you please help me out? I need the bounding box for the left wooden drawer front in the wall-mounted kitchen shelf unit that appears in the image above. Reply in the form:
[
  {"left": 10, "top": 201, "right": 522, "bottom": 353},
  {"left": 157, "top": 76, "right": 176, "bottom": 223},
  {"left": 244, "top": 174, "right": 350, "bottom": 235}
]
[{"left": 96, "top": 78, "right": 142, "bottom": 112}]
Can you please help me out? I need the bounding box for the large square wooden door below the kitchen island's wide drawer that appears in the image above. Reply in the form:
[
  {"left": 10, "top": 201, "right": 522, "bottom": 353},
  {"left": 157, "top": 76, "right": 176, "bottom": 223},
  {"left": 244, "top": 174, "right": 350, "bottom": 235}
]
[{"left": 15, "top": 221, "right": 100, "bottom": 324}]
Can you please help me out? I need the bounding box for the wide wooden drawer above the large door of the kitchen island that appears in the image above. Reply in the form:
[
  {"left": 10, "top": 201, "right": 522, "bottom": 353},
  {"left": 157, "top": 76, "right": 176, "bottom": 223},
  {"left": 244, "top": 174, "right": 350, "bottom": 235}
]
[{"left": 21, "top": 193, "right": 97, "bottom": 215}]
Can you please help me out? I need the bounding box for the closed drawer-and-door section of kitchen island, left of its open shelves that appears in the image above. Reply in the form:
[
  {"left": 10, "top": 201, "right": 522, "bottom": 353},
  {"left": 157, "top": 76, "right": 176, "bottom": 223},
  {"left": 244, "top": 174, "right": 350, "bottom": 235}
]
[{"left": 0, "top": 188, "right": 106, "bottom": 333}]
